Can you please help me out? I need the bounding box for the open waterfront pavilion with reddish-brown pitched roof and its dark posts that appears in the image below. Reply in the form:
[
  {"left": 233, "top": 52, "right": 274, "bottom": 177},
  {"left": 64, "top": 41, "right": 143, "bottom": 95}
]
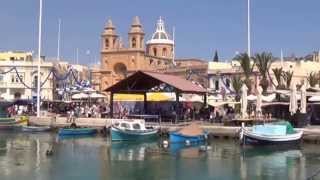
[{"left": 105, "top": 71, "right": 207, "bottom": 116}]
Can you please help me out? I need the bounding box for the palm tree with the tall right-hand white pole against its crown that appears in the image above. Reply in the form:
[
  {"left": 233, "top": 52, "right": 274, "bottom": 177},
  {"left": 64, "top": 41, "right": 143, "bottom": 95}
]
[{"left": 234, "top": 53, "right": 254, "bottom": 92}]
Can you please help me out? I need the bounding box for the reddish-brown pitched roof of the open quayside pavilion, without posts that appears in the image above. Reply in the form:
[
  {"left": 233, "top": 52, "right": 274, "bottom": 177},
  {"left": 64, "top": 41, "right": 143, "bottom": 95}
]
[{"left": 105, "top": 71, "right": 207, "bottom": 94}]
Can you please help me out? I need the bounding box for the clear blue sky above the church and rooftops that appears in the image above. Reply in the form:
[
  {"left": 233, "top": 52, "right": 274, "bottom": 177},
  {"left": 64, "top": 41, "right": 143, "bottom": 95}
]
[{"left": 0, "top": 0, "right": 320, "bottom": 64}]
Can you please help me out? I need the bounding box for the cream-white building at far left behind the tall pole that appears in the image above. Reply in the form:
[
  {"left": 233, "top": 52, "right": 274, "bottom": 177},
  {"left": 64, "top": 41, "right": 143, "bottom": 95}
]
[{"left": 0, "top": 56, "right": 53, "bottom": 100}]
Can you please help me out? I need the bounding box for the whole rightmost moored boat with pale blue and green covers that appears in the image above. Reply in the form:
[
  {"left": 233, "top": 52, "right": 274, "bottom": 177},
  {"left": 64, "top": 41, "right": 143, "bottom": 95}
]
[{"left": 240, "top": 121, "right": 303, "bottom": 145}]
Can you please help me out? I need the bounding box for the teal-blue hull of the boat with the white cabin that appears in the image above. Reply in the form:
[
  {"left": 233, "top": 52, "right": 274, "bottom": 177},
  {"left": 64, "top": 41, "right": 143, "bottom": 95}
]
[{"left": 111, "top": 127, "right": 158, "bottom": 141}]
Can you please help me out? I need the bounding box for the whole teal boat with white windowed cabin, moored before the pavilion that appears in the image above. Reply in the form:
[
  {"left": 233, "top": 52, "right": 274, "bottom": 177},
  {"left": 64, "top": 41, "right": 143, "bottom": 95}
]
[{"left": 111, "top": 119, "right": 159, "bottom": 141}]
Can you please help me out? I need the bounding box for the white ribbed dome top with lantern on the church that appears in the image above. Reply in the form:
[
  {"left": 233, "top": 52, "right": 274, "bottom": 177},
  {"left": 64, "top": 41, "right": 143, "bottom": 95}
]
[{"left": 147, "top": 17, "right": 174, "bottom": 45}]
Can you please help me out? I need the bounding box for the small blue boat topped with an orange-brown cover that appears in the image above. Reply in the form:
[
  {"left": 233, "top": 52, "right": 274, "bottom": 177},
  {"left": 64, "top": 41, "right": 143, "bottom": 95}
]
[{"left": 169, "top": 123, "right": 207, "bottom": 143}]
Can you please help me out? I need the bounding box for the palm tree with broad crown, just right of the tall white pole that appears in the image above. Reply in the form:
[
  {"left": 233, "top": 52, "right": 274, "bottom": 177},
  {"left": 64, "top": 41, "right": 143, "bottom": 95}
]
[{"left": 253, "top": 52, "right": 273, "bottom": 94}]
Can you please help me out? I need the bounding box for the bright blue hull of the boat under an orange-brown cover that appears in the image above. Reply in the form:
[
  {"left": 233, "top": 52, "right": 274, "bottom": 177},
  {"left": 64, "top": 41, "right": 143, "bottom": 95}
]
[{"left": 169, "top": 132, "right": 206, "bottom": 143}]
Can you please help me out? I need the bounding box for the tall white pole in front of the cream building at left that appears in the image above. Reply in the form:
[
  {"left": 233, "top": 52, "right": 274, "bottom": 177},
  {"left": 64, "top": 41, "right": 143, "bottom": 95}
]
[{"left": 37, "top": 0, "right": 42, "bottom": 117}]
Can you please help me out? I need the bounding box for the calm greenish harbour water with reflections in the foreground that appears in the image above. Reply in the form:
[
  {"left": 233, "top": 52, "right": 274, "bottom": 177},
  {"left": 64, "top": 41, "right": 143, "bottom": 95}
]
[{"left": 0, "top": 132, "right": 320, "bottom": 180}]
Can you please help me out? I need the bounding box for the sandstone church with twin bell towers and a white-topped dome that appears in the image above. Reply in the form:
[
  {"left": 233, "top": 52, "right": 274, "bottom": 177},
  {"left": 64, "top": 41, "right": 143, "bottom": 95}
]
[{"left": 99, "top": 16, "right": 207, "bottom": 90}]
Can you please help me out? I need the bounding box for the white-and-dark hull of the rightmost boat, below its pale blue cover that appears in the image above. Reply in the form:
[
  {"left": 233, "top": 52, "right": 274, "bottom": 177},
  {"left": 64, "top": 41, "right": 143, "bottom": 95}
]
[{"left": 243, "top": 131, "right": 303, "bottom": 145}]
